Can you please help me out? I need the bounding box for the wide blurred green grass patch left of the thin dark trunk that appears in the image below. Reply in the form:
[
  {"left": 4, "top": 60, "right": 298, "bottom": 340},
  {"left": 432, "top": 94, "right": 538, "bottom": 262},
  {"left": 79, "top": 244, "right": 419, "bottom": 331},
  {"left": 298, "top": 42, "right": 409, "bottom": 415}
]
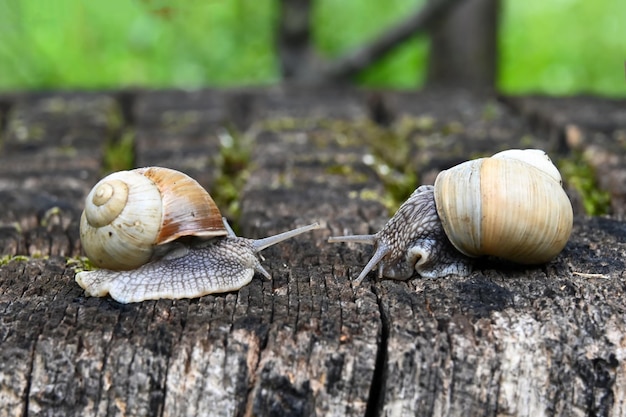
[{"left": 0, "top": 0, "right": 277, "bottom": 89}]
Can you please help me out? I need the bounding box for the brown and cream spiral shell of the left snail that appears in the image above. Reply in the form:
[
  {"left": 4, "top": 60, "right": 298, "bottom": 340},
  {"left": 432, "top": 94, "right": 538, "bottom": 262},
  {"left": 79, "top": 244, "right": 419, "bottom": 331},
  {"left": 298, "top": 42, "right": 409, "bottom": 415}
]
[{"left": 80, "top": 167, "right": 228, "bottom": 270}]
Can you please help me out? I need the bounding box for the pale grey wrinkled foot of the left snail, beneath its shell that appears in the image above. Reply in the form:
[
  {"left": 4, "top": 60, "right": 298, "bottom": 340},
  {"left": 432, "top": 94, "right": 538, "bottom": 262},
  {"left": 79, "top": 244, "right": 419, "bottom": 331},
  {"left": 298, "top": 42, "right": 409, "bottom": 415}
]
[{"left": 76, "top": 237, "right": 270, "bottom": 303}]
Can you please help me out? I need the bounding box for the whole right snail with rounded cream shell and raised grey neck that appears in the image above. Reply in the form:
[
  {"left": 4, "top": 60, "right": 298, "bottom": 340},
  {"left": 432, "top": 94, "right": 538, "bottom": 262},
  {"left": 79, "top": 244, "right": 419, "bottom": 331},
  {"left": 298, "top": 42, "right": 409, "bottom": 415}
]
[{"left": 329, "top": 149, "right": 573, "bottom": 284}]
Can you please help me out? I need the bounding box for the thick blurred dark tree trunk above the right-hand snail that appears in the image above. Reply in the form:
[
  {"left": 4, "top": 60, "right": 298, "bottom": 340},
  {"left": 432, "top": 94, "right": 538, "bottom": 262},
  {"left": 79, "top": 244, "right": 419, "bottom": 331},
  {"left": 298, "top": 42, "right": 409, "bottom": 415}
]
[{"left": 427, "top": 0, "right": 499, "bottom": 91}]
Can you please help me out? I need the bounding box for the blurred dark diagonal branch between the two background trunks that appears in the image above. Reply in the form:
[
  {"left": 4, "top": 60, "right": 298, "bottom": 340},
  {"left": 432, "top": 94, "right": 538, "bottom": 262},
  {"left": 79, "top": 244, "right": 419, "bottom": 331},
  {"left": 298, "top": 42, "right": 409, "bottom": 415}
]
[{"left": 311, "top": 0, "right": 463, "bottom": 82}]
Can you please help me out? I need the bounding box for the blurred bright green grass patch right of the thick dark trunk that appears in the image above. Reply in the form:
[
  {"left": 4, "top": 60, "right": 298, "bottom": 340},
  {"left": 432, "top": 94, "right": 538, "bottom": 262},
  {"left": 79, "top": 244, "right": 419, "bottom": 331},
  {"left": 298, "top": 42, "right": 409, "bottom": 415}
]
[{"left": 499, "top": 0, "right": 626, "bottom": 96}]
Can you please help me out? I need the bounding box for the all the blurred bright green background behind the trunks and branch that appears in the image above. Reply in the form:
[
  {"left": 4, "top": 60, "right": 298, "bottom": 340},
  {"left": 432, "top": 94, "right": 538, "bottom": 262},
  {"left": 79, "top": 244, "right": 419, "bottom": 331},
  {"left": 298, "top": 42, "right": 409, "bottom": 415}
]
[{"left": 0, "top": 0, "right": 626, "bottom": 97}]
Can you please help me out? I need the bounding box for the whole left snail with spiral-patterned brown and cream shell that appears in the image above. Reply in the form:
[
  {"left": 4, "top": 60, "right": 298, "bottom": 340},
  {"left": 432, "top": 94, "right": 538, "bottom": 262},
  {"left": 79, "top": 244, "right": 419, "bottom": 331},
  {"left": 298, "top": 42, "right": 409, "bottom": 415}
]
[{"left": 76, "top": 167, "right": 319, "bottom": 303}]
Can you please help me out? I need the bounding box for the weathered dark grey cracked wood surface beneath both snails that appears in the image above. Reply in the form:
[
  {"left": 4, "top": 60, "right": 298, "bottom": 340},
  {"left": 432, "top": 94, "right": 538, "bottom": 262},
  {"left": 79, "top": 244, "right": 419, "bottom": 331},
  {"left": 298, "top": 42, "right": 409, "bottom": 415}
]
[{"left": 0, "top": 89, "right": 626, "bottom": 416}]
